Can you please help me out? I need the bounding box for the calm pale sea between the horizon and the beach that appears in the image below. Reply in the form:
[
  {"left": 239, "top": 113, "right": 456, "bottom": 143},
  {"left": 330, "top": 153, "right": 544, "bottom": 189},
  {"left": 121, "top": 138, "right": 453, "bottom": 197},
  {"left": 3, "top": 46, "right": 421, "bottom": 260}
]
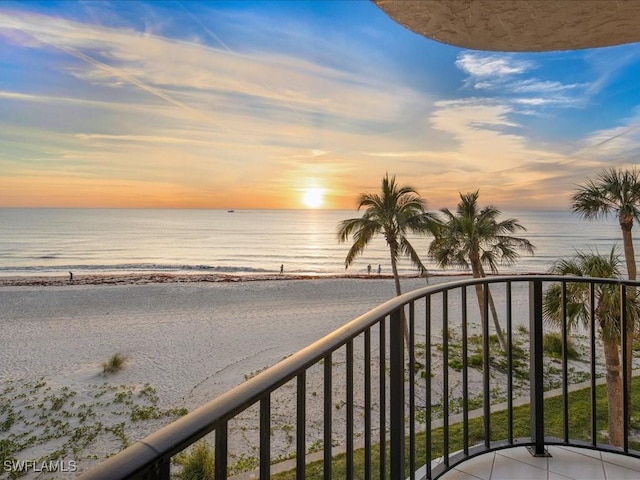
[{"left": 0, "top": 208, "right": 622, "bottom": 276}]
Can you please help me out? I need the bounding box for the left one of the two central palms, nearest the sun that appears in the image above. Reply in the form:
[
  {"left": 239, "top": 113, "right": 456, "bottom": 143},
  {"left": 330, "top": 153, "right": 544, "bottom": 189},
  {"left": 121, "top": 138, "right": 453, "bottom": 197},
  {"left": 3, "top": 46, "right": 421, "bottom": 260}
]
[{"left": 338, "top": 173, "right": 436, "bottom": 342}]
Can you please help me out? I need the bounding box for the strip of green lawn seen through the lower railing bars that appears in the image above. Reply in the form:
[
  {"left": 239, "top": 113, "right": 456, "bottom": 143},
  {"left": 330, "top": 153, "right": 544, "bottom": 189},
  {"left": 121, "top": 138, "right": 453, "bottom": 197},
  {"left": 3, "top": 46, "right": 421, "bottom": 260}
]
[{"left": 272, "top": 378, "right": 640, "bottom": 480}]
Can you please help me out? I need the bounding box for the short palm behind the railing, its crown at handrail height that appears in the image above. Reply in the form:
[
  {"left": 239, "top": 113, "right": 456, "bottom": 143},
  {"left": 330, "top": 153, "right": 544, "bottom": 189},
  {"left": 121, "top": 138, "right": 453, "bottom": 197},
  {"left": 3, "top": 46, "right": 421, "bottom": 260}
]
[{"left": 543, "top": 247, "right": 640, "bottom": 446}]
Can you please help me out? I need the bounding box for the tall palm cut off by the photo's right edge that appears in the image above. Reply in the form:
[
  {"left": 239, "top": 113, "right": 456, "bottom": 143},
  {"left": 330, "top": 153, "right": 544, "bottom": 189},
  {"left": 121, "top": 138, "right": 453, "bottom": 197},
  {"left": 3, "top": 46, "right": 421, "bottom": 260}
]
[{"left": 572, "top": 168, "right": 640, "bottom": 410}]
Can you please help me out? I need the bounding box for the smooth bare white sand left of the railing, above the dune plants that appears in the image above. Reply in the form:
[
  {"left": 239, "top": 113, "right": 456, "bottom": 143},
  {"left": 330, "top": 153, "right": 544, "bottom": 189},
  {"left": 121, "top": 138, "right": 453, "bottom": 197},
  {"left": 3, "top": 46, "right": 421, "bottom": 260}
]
[{"left": 0, "top": 279, "right": 444, "bottom": 409}]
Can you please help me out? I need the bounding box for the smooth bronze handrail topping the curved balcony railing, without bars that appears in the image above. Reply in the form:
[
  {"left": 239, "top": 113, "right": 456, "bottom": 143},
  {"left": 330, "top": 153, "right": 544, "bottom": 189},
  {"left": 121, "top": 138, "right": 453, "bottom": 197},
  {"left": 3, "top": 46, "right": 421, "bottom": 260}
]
[{"left": 79, "top": 274, "right": 640, "bottom": 480}]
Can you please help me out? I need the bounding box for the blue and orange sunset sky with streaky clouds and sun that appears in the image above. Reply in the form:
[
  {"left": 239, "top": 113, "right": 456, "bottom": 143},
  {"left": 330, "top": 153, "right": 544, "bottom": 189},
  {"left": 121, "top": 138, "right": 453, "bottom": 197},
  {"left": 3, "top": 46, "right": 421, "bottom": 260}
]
[{"left": 0, "top": 0, "right": 640, "bottom": 210}]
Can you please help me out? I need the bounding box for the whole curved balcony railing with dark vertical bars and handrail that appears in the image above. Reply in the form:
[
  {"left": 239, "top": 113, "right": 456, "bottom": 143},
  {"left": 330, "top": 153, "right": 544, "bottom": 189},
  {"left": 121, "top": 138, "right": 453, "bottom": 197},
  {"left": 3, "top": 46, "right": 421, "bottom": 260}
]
[{"left": 81, "top": 275, "right": 640, "bottom": 480}]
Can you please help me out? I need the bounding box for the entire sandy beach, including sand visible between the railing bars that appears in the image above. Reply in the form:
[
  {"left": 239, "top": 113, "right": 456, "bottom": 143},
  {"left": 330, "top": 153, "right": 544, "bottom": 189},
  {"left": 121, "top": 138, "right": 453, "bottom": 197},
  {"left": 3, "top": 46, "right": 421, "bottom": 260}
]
[{"left": 0, "top": 274, "right": 616, "bottom": 478}]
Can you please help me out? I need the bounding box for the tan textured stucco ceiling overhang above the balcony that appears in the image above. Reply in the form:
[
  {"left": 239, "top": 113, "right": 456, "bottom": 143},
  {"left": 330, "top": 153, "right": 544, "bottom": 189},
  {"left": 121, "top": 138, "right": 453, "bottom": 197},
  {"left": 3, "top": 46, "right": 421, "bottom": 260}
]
[{"left": 373, "top": 0, "right": 640, "bottom": 52}]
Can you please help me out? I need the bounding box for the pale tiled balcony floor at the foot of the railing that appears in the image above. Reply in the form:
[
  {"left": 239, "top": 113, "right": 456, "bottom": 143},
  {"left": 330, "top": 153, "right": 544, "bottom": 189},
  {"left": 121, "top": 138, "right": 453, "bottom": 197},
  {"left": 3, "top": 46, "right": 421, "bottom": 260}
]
[{"left": 432, "top": 446, "right": 640, "bottom": 480}]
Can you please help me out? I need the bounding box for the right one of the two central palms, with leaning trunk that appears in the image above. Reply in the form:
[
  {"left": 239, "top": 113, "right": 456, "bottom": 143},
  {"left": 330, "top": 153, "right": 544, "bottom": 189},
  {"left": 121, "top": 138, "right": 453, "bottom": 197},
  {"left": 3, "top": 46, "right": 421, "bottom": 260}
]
[{"left": 429, "top": 190, "right": 535, "bottom": 351}]
